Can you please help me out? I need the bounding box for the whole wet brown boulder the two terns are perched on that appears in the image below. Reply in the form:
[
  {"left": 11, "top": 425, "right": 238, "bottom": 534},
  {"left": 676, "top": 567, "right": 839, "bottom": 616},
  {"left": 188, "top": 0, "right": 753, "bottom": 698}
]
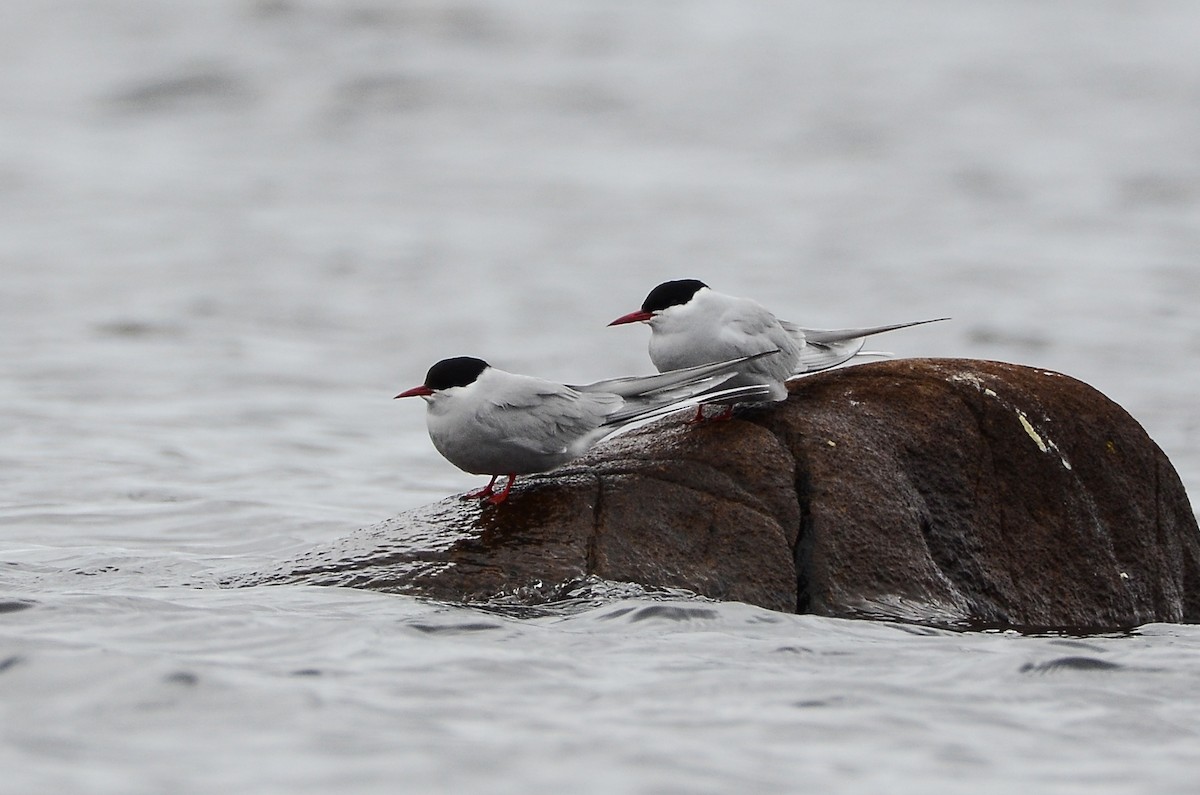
[{"left": 253, "top": 359, "right": 1200, "bottom": 629}]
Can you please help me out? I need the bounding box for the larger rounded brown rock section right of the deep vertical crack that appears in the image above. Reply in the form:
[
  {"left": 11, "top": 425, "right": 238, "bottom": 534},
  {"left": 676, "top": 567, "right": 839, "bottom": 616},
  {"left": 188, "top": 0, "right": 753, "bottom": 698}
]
[{"left": 754, "top": 360, "right": 1200, "bottom": 627}]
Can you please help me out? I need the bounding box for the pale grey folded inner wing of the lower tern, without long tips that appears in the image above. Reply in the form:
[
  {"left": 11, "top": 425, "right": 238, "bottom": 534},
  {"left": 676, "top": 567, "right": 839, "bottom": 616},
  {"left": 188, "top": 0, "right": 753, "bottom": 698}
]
[{"left": 475, "top": 381, "right": 624, "bottom": 455}]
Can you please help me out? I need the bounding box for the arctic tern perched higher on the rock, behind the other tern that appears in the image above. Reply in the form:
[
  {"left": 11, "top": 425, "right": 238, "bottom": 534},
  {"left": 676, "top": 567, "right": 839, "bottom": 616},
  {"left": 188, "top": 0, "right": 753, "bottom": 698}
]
[{"left": 608, "top": 279, "right": 948, "bottom": 419}]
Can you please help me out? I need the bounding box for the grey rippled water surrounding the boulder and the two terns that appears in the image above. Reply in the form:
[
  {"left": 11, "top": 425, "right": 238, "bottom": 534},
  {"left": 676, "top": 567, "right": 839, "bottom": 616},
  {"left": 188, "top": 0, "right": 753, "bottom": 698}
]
[{"left": 0, "top": 0, "right": 1200, "bottom": 795}]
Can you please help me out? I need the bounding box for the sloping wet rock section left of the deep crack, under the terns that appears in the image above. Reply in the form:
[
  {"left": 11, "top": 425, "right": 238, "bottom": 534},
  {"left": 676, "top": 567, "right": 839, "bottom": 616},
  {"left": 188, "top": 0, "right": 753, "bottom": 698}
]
[{"left": 269, "top": 419, "right": 799, "bottom": 612}]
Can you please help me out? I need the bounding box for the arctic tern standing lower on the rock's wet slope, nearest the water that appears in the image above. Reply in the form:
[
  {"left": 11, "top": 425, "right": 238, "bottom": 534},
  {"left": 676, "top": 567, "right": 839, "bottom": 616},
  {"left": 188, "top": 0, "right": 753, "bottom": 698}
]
[{"left": 396, "top": 349, "right": 778, "bottom": 504}]
